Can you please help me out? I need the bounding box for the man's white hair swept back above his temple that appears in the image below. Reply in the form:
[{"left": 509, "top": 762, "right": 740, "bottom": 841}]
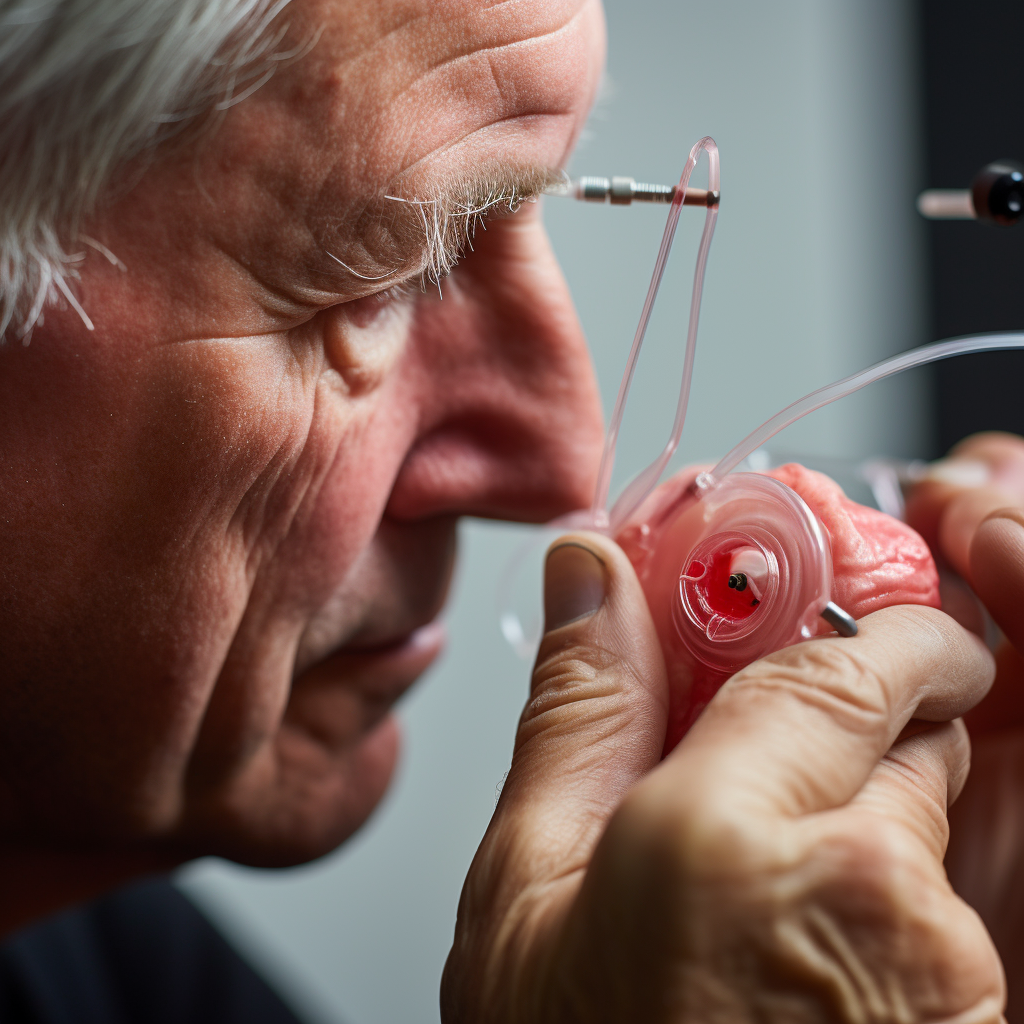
[{"left": 0, "top": 0, "right": 303, "bottom": 343}]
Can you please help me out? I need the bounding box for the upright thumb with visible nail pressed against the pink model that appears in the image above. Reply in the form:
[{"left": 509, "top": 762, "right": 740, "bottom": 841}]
[{"left": 496, "top": 534, "right": 668, "bottom": 882}]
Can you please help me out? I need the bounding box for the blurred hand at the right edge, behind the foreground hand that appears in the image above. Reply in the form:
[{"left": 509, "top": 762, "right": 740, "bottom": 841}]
[{"left": 907, "top": 433, "right": 1024, "bottom": 1021}]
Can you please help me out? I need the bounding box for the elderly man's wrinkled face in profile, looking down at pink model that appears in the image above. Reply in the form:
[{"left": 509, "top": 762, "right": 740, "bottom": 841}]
[{"left": 0, "top": 0, "right": 603, "bottom": 863}]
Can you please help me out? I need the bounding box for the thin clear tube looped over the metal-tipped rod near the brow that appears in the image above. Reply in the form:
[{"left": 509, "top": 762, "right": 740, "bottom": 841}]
[{"left": 590, "top": 135, "right": 721, "bottom": 534}]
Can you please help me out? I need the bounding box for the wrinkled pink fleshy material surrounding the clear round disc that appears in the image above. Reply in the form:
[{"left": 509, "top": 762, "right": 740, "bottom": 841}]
[{"left": 617, "top": 464, "right": 940, "bottom": 752}]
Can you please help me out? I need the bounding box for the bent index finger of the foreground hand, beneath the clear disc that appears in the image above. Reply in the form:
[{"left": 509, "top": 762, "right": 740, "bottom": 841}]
[{"left": 651, "top": 605, "right": 994, "bottom": 816}]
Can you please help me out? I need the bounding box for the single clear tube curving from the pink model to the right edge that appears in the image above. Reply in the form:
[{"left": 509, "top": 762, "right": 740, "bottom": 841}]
[{"left": 697, "top": 333, "right": 1024, "bottom": 489}]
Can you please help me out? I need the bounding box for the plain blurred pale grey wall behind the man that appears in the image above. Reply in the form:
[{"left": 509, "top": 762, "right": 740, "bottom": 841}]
[{"left": 179, "top": 0, "right": 930, "bottom": 1024}]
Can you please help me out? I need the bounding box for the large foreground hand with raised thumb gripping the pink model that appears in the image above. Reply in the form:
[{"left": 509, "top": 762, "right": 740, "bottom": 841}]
[{"left": 441, "top": 534, "right": 1004, "bottom": 1024}]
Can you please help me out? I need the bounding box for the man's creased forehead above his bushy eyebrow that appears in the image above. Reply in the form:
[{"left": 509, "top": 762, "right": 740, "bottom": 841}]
[{"left": 276, "top": 0, "right": 603, "bottom": 199}]
